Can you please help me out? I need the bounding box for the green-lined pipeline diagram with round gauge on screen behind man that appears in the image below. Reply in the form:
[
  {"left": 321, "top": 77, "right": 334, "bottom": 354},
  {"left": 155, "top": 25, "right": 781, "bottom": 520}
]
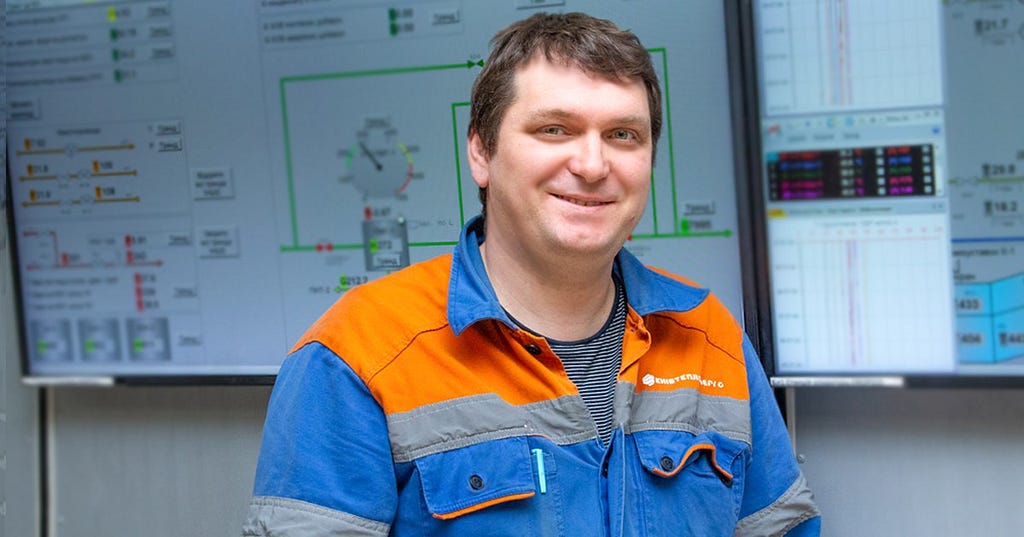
[{"left": 279, "top": 48, "right": 733, "bottom": 272}]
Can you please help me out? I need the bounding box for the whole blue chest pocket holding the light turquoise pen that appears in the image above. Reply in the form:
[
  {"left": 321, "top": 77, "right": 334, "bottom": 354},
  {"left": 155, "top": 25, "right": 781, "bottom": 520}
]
[{"left": 416, "top": 438, "right": 561, "bottom": 536}]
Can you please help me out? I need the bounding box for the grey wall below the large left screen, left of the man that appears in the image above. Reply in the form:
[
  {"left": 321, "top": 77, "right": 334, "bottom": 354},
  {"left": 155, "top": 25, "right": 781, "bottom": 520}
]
[{"left": 51, "top": 386, "right": 270, "bottom": 537}]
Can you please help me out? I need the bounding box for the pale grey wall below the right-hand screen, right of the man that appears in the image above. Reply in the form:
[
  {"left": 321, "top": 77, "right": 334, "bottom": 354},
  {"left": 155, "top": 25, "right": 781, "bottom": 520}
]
[{"left": 796, "top": 388, "right": 1024, "bottom": 537}]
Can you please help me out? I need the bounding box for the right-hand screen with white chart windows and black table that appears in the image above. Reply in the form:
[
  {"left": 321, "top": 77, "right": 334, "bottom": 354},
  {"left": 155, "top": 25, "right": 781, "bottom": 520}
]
[{"left": 754, "top": 0, "right": 1024, "bottom": 385}]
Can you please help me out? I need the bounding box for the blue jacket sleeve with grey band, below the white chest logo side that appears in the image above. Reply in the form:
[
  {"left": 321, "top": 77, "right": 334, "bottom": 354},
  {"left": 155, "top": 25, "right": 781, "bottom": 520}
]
[{"left": 736, "top": 337, "right": 820, "bottom": 537}]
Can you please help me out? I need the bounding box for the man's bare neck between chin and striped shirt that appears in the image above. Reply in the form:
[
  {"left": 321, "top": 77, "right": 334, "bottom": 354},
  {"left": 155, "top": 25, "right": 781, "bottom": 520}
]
[{"left": 480, "top": 242, "right": 615, "bottom": 341}]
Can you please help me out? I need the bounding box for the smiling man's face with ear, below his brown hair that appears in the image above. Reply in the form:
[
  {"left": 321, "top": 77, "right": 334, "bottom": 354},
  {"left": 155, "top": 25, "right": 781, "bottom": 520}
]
[{"left": 468, "top": 55, "right": 653, "bottom": 256}]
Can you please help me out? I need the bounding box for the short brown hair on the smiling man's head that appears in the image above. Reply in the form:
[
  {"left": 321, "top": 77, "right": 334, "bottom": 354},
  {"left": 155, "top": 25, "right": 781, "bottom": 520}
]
[{"left": 469, "top": 13, "right": 662, "bottom": 212}]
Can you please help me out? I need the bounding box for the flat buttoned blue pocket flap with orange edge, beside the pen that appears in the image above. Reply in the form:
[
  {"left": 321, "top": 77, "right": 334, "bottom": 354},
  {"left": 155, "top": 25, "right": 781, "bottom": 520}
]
[{"left": 416, "top": 438, "right": 535, "bottom": 520}]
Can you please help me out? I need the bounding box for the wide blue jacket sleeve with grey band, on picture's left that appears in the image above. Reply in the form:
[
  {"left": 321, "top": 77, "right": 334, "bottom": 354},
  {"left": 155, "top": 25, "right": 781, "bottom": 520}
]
[{"left": 246, "top": 342, "right": 397, "bottom": 535}]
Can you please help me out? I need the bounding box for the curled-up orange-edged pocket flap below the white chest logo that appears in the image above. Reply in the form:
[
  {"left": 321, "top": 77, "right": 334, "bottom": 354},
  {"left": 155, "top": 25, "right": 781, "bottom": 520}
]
[{"left": 633, "top": 430, "right": 746, "bottom": 486}]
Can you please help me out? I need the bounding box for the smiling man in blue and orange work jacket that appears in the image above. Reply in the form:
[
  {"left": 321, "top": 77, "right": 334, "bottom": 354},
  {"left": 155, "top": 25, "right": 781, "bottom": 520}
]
[{"left": 245, "top": 13, "right": 819, "bottom": 536}]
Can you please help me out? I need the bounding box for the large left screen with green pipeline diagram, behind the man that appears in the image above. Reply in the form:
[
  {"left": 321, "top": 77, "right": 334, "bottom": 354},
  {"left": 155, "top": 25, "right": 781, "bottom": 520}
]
[{"left": 5, "top": 0, "right": 742, "bottom": 381}]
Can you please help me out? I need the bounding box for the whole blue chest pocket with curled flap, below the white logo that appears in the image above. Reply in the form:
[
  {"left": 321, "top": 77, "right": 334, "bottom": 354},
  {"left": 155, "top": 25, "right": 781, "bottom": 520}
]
[{"left": 633, "top": 430, "right": 750, "bottom": 536}]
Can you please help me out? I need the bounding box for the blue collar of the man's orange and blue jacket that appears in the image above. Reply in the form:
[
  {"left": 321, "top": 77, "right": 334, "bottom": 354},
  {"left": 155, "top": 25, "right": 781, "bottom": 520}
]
[{"left": 447, "top": 216, "right": 709, "bottom": 335}]
